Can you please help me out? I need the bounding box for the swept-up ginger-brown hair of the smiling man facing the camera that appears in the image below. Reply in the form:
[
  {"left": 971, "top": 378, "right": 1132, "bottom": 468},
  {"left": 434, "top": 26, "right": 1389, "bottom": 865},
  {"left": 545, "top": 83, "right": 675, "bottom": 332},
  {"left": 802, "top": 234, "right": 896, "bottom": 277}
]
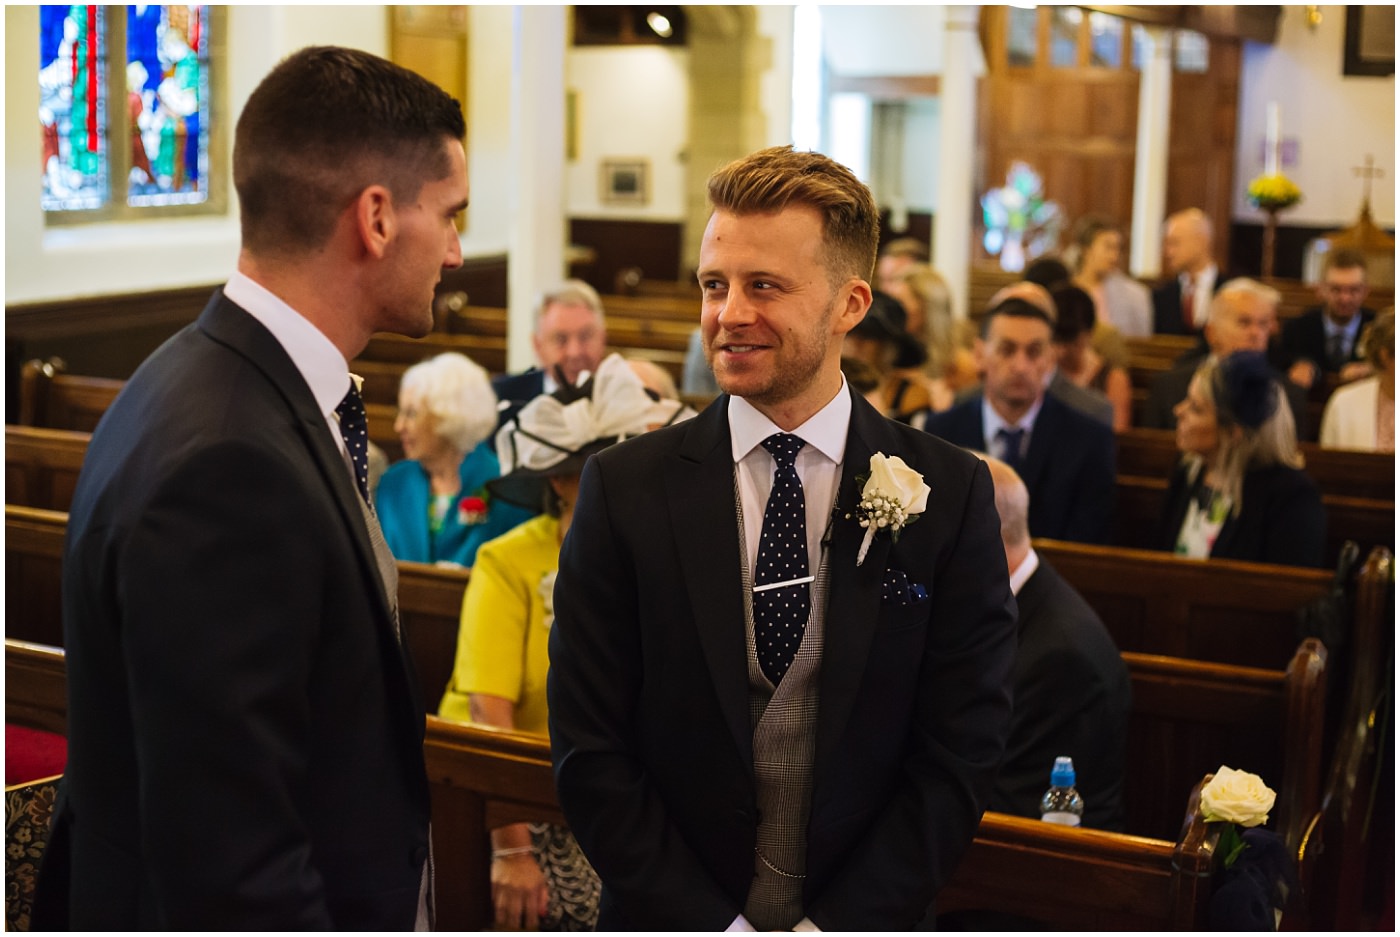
[{"left": 708, "top": 146, "right": 879, "bottom": 284}]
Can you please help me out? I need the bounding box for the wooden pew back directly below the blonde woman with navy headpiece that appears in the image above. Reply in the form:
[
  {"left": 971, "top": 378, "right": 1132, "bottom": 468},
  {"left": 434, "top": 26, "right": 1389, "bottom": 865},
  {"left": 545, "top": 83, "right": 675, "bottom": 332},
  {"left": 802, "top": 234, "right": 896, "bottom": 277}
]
[{"left": 1035, "top": 539, "right": 1333, "bottom": 669}]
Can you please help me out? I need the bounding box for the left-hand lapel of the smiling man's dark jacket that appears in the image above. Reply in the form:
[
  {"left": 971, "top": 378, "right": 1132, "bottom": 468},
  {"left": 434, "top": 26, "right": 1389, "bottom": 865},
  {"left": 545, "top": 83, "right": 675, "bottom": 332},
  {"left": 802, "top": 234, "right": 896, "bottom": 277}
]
[{"left": 666, "top": 396, "right": 753, "bottom": 770}]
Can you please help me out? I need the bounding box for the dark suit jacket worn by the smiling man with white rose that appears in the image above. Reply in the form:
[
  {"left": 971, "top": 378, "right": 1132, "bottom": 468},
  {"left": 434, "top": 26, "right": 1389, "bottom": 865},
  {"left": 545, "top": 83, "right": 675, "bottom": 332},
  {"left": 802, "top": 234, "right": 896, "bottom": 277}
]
[{"left": 549, "top": 394, "right": 1015, "bottom": 930}]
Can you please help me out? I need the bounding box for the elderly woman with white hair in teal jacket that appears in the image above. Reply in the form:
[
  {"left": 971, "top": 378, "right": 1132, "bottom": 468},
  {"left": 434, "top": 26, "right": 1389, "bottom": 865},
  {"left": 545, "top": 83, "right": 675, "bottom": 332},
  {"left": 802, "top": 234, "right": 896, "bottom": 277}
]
[{"left": 375, "top": 352, "right": 531, "bottom": 566}]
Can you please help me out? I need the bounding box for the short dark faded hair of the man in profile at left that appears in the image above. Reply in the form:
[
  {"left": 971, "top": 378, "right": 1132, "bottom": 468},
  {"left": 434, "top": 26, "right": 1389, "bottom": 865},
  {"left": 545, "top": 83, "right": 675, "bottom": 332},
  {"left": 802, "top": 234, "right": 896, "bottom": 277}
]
[{"left": 234, "top": 46, "right": 466, "bottom": 254}]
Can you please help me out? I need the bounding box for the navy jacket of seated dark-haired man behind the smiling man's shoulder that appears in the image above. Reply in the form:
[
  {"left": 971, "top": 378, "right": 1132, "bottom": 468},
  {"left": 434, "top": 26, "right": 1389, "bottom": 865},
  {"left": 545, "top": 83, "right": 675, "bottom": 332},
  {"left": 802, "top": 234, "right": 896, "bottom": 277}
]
[{"left": 924, "top": 394, "right": 1117, "bottom": 543}]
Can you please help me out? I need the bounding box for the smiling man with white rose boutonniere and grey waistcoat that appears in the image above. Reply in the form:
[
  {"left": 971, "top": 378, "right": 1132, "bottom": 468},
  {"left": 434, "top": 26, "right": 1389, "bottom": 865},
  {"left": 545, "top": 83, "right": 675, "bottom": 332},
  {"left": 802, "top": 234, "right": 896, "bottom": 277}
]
[{"left": 549, "top": 147, "right": 1015, "bottom": 930}]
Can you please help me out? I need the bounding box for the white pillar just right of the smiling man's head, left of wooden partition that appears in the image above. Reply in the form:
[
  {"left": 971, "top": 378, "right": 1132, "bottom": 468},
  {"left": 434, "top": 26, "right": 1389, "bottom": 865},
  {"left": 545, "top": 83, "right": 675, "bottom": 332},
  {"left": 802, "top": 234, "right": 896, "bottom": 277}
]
[{"left": 932, "top": 4, "right": 986, "bottom": 318}]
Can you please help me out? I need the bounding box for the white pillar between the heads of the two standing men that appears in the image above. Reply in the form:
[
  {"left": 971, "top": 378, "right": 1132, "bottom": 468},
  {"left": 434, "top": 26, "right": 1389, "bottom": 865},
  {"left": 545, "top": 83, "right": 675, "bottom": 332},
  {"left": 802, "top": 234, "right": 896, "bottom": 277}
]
[{"left": 505, "top": 6, "right": 568, "bottom": 371}]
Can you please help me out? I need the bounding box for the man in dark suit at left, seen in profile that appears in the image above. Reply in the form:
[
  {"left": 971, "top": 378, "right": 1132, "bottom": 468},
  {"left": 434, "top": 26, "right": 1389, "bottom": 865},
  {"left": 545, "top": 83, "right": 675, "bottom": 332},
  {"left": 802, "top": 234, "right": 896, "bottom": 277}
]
[{"left": 34, "top": 48, "right": 468, "bottom": 931}]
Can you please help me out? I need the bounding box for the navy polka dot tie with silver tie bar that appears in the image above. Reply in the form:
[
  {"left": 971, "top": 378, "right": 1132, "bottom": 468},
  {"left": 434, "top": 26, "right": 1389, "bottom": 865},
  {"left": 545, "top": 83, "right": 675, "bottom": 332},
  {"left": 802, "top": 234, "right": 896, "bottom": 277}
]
[{"left": 753, "top": 433, "right": 812, "bottom": 686}]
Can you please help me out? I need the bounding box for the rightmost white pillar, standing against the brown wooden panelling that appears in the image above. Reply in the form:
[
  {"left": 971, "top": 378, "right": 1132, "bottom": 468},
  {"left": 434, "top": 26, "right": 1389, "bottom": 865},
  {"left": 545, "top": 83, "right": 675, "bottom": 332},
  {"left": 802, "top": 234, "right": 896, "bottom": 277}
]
[{"left": 1128, "top": 27, "right": 1172, "bottom": 279}]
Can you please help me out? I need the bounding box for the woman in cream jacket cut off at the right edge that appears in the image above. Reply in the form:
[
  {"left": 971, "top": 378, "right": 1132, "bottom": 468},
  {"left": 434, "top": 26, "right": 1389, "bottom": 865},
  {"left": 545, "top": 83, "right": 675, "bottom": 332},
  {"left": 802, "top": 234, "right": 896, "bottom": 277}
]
[{"left": 1322, "top": 307, "right": 1396, "bottom": 452}]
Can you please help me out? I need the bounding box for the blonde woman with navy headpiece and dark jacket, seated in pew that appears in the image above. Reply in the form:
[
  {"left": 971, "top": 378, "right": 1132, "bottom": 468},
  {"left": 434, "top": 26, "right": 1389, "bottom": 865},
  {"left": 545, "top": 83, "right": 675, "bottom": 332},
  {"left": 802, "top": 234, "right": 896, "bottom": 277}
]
[{"left": 1159, "top": 352, "right": 1326, "bottom": 566}]
